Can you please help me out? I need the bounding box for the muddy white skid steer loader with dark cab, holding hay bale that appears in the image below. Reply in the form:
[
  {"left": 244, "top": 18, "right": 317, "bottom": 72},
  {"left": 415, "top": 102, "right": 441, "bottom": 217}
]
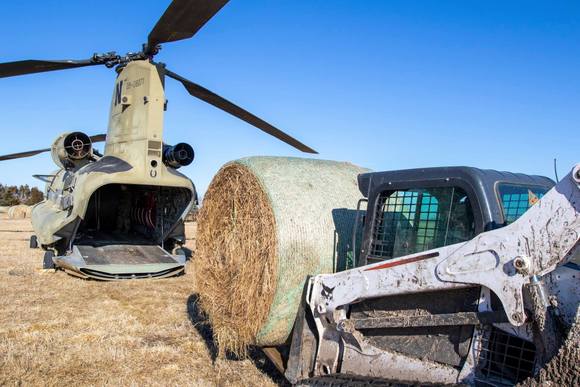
[{"left": 282, "top": 164, "right": 580, "bottom": 386}]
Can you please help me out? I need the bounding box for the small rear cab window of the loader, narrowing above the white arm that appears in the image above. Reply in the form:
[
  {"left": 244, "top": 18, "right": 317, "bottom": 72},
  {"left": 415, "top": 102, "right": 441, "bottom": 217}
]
[{"left": 498, "top": 183, "right": 548, "bottom": 225}]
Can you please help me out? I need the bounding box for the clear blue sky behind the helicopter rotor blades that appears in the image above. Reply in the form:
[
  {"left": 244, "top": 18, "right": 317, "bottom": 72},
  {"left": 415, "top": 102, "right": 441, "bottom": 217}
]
[{"left": 0, "top": 0, "right": 580, "bottom": 193}]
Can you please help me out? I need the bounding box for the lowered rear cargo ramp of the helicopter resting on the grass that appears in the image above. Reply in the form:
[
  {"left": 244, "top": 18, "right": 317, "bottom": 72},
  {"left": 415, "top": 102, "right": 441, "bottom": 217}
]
[{"left": 53, "top": 245, "right": 185, "bottom": 281}]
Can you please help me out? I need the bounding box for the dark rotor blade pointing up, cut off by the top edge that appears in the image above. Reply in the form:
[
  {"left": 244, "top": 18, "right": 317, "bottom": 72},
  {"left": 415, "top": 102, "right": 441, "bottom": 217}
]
[{"left": 147, "top": 0, "right": 229, "bottom": 50}]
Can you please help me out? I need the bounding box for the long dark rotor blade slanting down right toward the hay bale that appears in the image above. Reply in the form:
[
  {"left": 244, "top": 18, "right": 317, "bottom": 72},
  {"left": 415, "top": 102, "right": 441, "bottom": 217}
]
[{"left": 165, "top": 70, "right": 318, "bottom": 153}]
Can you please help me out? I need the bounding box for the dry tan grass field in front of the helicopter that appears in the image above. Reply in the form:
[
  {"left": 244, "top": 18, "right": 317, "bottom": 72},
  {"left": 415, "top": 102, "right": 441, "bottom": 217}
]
[{"left": 0, "top": 215, "right": 283, "bottom": 386}]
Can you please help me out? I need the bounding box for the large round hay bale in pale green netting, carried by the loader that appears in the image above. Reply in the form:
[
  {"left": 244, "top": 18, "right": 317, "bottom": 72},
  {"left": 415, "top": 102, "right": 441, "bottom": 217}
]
[{"left": 195, "top": 157, "right": 368, "bottom": 354}]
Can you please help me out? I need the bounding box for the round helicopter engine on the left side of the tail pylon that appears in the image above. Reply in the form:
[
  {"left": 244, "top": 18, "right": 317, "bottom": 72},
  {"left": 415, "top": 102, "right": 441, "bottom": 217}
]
[{"left": 51, "top": 132, "right": 93, "bottom": 169}]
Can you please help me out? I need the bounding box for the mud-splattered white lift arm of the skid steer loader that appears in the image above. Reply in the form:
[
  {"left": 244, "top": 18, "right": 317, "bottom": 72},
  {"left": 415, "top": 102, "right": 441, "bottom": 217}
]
[{"left": 305, "top": 164, "right": 580, "bottom": 383}]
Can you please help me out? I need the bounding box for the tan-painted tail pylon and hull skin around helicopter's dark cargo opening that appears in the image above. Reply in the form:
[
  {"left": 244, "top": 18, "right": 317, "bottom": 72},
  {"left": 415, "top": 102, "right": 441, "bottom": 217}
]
[{"left": 31, "top": 60, "right": 196, "bottom": 272}]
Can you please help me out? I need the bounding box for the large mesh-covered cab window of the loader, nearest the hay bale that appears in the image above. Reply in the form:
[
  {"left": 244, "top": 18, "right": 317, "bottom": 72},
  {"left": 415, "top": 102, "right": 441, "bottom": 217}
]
[{"left": 369, "top": 187, "right": 475, "bottom": 261}]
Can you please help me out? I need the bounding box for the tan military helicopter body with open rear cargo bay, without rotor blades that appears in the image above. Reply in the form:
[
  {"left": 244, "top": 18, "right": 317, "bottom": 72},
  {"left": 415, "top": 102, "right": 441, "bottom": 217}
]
[{"left": 32, "top": 60, "right": 196, "bottom": 277}]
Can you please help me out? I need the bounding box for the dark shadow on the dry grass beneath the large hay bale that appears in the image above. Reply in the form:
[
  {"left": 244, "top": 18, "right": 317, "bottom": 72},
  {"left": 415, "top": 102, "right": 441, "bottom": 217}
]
[{"left": 187, "top": 293, "right": 290, "bottom": 386}]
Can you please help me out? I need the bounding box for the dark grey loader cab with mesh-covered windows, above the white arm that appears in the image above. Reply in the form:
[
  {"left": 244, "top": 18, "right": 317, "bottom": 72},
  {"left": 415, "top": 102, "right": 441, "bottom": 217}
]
[{"left": 353, "top": 167, "right": 554, "bottom": 266}]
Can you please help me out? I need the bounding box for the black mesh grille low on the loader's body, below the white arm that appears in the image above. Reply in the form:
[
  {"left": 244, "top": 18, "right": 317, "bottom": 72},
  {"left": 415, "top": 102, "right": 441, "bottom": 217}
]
[{"left": 476, "top": 327, "right": 536, "bottom": 385}]
